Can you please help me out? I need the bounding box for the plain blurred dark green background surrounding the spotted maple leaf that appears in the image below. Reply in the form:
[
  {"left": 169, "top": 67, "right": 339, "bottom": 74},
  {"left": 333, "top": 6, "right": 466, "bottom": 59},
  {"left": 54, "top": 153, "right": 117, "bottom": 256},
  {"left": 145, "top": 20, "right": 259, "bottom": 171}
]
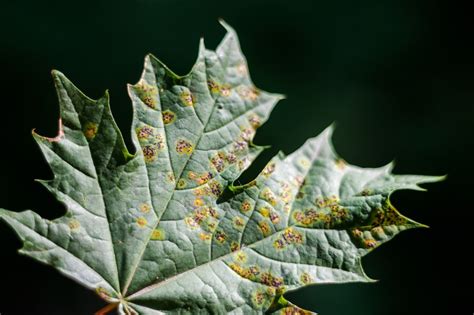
[{"left": 0, "top": 0, "right": 474, "bottom": 315}]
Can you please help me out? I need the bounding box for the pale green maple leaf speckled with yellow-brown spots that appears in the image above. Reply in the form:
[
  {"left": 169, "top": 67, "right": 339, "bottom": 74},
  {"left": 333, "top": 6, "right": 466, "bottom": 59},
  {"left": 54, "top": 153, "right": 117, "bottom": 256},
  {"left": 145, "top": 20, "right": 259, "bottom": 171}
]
[{"left": 0, "top": 23, "right": 442, "bottom": 314}]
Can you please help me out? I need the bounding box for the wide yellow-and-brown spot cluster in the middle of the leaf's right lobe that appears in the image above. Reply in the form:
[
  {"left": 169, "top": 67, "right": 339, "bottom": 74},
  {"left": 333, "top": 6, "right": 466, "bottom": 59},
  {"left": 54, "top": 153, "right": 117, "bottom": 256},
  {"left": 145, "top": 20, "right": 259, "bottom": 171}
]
[{"left": 293, "top": 196, "right": 351, "bottom": 228}]
